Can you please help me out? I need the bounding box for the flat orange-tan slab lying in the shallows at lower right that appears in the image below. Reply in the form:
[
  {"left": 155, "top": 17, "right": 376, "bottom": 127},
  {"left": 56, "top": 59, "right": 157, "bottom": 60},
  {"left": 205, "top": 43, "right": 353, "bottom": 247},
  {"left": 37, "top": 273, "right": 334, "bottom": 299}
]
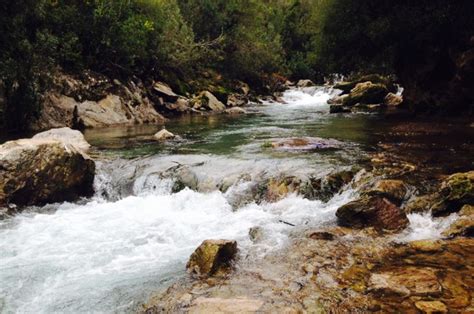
[{"left": 369, "top": 267, "right": 442, "bottom": 296}]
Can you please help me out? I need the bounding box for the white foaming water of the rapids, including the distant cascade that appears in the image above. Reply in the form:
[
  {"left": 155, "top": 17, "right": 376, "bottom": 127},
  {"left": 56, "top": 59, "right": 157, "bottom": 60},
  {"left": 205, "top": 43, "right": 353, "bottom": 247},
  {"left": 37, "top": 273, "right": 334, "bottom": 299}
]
[{"left": 0, "top": 89, "right": 456, "bottom": 313}]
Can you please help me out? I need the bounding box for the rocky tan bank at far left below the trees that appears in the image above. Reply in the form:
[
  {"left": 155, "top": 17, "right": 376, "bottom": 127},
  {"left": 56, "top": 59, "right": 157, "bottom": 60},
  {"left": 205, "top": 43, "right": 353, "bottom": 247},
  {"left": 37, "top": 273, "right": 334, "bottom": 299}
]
[{"left": 29, "top": 71, "right": 254, "bottom": 131}]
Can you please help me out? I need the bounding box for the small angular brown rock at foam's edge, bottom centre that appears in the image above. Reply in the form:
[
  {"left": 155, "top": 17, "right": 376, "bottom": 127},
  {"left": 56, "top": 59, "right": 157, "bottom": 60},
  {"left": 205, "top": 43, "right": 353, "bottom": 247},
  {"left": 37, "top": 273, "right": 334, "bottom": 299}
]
[{"left": 186, "top": 240, "right": 237, "bottom": 276}]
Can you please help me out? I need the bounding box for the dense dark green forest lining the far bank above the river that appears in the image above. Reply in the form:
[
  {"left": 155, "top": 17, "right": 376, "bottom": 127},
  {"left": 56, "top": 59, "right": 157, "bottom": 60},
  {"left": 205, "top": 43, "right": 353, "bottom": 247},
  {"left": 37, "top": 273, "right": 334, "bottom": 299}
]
[{"left": 0, "top": 0, "right": 474, "bottom": 129}]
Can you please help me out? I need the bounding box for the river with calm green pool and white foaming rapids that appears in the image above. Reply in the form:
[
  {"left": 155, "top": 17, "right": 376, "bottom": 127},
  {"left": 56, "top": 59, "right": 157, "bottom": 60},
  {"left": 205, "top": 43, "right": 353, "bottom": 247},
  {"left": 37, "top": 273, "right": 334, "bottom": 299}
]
[{"left": 0, "top": 87, "right": 471, "bottom": 313}]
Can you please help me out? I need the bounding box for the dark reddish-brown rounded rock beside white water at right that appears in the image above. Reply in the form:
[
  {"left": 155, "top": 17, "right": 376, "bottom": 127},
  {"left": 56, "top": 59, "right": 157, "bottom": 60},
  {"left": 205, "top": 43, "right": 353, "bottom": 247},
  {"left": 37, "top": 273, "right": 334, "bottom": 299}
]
[{"left": 336, "top": 196, "right": 408, "bottom": 230}]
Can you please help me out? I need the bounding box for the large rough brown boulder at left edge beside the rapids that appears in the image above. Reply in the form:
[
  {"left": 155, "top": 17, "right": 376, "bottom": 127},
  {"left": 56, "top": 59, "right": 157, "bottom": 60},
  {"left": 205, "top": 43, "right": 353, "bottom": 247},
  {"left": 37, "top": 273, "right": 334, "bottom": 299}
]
[{"left": 0, "top": 131, "right": 95, "bottom": 207}]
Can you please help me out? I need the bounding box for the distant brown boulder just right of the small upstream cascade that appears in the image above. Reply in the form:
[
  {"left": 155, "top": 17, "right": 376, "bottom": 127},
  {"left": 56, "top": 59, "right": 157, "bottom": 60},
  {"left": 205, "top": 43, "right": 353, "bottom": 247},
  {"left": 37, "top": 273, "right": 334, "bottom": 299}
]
[{"left": 343, "top": 82, "right": 388, "bottom": 106}]
